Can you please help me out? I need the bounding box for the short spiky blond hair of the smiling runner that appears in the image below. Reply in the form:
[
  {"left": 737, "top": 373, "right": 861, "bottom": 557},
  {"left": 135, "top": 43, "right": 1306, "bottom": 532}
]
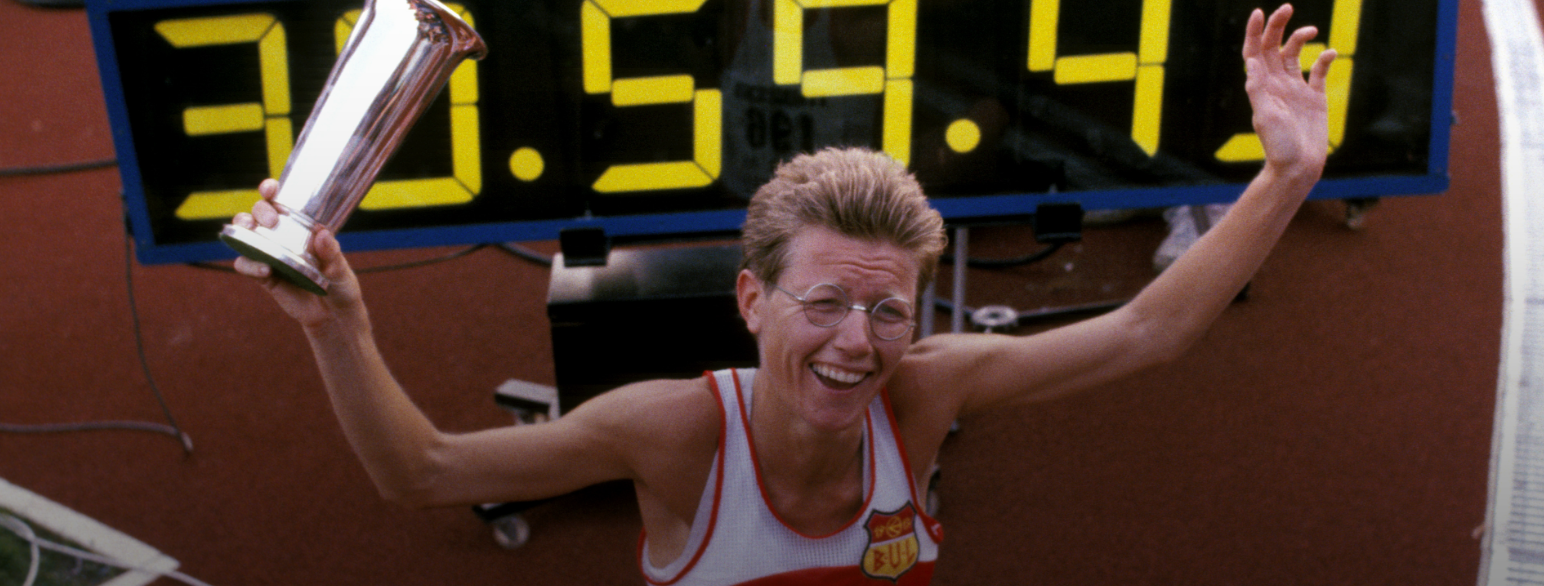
[{"left": 740, "top": 148, "right": 946, "bottom": 291}]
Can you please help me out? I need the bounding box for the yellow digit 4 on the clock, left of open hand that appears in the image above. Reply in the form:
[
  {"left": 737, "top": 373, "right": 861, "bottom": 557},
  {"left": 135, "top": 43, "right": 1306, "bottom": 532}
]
[{"left": 1028, "top": 0, "right": 1172, "bottom": 156}]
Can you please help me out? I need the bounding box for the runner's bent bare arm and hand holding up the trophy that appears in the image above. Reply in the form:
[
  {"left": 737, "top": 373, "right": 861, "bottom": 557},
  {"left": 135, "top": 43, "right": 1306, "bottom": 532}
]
[{"left": 233, "top": 180, "right": 648, "bottom": 506}]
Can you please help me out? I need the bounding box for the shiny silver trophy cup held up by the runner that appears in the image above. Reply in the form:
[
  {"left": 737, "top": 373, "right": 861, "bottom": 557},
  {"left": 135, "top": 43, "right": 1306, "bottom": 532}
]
[{"left": 219, "top": 0, "right": 488, "bottom": 295}]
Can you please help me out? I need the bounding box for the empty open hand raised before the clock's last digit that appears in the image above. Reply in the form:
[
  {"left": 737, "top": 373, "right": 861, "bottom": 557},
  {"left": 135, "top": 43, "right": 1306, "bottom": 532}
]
[{"left": 1243, "top": 5, "right": 1336, "bottom": 174}]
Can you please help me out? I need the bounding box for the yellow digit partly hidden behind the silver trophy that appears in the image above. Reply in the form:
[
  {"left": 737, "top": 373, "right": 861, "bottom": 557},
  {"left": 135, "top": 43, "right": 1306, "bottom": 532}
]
[{"left": 332, "top": 3, "right": 482, "bottom": 210}]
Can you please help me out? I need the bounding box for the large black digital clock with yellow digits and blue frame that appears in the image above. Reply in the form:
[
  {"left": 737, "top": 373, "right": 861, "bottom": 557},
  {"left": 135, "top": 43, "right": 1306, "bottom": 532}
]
[{"left": 86, "top": 0, "right": 1458, "bottom": 262}]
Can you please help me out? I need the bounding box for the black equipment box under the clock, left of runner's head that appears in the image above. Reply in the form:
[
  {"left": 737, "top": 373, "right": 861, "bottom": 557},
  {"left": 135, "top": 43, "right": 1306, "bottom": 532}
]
[{"left": 547, "top": 245, "right": 757, "bottom": 412}]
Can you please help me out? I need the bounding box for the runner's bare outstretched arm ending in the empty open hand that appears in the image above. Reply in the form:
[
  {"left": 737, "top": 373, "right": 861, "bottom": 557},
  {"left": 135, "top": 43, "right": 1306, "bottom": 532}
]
[{"left": 906, "top": 5, "right": 1336, "bottom": 412}]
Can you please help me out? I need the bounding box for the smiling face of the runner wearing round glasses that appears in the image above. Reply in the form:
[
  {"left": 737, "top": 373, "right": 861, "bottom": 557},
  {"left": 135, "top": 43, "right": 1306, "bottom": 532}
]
[{"left": 736, "top": 227, "right": 919, "bottom": 430}]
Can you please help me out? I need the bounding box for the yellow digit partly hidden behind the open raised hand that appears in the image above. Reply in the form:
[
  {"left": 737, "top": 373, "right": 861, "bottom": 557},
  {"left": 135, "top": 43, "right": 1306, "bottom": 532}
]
[{"left": 1217, "top": 0, "right": 1362, "bottom": 163}]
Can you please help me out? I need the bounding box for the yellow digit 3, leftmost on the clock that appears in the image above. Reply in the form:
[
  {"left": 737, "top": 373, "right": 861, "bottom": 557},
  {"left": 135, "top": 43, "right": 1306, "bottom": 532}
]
[{"left": 154, "top": 14, "right": 295, "bottom": 221}]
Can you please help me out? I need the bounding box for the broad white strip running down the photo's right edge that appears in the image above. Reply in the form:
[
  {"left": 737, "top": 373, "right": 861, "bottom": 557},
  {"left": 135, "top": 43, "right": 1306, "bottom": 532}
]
[{"left": 1479, "top": 0, "right": 1544, "bottom": 586}]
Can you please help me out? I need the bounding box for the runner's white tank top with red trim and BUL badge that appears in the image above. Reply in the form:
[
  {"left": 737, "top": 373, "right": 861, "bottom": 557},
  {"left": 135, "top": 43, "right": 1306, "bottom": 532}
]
[{"left": 639, "top": 369, "right": 943, "bottom": 586}]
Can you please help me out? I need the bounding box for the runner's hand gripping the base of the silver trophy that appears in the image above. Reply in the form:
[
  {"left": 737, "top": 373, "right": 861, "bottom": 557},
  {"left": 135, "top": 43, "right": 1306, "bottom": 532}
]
[{"left": 232, "top": 179, "right": 364, "bottom": 328}]
